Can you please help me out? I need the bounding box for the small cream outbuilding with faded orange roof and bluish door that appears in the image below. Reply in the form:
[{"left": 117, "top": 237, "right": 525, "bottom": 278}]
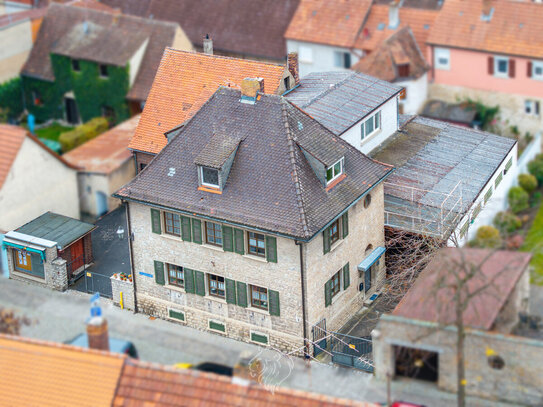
[{"left": 62, "top": 115, "right": 140, "bottom": 218}]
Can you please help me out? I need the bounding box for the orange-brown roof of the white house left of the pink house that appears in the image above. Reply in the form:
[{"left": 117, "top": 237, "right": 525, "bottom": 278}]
[{"left": 285, "top": 0, "right": 372, "bottom": 48}]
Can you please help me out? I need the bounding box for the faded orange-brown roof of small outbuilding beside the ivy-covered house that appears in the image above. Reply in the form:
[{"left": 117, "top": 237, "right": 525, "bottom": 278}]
[{"left": 62, "top": 115, "right": 140, "bottom": 174}]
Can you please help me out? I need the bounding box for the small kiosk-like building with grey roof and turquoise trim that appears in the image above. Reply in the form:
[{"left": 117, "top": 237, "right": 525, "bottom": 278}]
[{"left": 3, "top": 212, "right": 95, "bottom": 291}]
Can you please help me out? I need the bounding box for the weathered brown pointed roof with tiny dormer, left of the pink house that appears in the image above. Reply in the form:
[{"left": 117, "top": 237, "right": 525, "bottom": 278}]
[{"left": 352, "top": 27, "right": 430, "bottom": 82}]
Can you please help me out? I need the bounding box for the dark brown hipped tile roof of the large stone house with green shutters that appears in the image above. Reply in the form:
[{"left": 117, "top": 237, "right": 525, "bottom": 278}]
[{"left": 117, "top": 87, "right": 391, "bottom": 240}]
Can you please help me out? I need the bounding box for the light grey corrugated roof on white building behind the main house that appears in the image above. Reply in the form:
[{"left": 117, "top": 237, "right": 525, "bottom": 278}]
[{"left": 286, "top": 72, "right": 401, "bottom": 135}]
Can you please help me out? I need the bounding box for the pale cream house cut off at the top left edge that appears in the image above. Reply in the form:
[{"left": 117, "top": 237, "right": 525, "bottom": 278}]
[{"left": 0, "top": 8, "right": 46, "bottom": 84}]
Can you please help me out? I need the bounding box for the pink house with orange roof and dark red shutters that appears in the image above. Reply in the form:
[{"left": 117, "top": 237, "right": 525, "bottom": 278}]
[{"left": 428, "top": 0, "right": 543, "bottom": 134}]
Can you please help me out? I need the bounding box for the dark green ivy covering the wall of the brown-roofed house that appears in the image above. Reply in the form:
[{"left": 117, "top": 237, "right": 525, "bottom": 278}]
[{"left": 23, "top": 54, "right": 130, "bottom": 123}]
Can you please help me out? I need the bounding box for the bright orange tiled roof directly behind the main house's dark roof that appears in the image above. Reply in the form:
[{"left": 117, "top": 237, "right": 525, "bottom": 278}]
[{"left": 129, "top": 48, "right": 286, "bottom": 154}]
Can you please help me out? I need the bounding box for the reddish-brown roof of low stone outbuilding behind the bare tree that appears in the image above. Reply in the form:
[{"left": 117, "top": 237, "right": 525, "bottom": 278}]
[{"left": 392, "top": 248, "right": 532, "bottom": 330}]
